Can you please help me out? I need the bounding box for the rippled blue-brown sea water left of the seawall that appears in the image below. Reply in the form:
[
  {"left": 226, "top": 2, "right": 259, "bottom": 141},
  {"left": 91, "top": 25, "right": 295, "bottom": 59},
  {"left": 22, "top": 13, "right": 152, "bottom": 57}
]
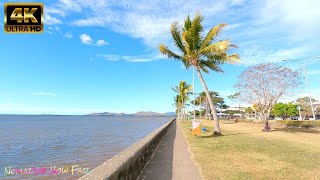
[{"left": 0, "top": 115, "right": 171, "bottom": 179}]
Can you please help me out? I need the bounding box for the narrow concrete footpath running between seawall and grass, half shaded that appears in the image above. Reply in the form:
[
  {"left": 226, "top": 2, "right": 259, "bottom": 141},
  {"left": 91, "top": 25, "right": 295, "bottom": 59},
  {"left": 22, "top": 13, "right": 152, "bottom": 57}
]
[{"left": 139, "top": 122, "right": 201, "bottom": 180}]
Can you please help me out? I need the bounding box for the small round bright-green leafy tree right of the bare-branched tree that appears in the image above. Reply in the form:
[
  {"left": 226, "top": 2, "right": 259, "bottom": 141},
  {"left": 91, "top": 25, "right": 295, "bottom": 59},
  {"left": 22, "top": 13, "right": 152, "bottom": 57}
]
[{"left": 272, "top": 103, "right": 299, "bottom": 120}]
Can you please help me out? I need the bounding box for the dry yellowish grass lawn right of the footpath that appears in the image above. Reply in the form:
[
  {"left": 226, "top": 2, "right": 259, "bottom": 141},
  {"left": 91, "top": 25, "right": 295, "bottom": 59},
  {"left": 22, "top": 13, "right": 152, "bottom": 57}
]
[{"left": 180, "top": 121, "right": 320, "bottom": 179}]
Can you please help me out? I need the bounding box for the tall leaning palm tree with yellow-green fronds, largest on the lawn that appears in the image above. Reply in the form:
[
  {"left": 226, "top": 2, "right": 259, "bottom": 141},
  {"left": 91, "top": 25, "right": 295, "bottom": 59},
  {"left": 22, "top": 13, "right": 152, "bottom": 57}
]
[{"left": 159, "top": 14, "right": 239, "bottom": 135}]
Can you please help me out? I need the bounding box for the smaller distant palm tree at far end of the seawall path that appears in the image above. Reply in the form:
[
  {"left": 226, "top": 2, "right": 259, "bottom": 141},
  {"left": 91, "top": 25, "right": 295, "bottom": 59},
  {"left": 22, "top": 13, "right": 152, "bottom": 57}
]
[{"left": 172, "top": 81, "right": 192, "bottom": 120}]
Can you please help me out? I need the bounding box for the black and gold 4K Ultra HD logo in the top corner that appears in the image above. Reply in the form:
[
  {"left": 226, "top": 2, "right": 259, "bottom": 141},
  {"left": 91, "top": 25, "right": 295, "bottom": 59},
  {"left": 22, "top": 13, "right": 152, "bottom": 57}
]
[{"left": 4, "top": 3, "right": 43, "bottom": 33}]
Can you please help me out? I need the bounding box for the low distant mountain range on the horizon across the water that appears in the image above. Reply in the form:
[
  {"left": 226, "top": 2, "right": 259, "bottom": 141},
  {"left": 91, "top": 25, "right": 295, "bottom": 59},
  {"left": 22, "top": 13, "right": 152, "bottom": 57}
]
[{"left": 88, "top": 111, "right": 176, "bottom": 117}]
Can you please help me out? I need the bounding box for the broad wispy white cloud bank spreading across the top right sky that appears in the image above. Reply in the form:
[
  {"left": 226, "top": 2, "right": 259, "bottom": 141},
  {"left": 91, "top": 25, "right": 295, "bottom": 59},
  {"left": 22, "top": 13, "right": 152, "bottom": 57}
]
[{"left": 44, "top": 0, "right": 320, "bottom": 65}]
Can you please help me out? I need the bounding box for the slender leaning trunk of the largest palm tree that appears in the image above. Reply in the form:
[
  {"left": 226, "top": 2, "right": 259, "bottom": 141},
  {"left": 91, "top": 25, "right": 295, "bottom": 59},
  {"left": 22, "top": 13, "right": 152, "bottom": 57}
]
[{"left": 195, "top": 66, "right": 221, "bottom": 135}]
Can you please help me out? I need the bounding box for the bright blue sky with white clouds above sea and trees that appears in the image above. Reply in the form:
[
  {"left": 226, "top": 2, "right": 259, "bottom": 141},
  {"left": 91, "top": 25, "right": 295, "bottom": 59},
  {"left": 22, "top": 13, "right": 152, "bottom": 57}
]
[{"left": 0, "top": 0, "right": 320, "bottom": 114}]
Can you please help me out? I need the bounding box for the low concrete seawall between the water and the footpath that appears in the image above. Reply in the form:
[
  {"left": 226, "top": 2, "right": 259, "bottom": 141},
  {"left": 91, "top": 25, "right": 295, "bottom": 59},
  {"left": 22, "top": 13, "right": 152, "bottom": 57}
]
[{"left": 80, "top": 119, "right": 175, "bottom": 180}]
